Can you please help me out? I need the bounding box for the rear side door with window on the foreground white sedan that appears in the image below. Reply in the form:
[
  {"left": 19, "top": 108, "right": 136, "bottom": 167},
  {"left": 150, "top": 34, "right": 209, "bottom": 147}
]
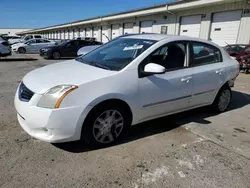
[{"left": 190, "top": 42, "right": 226, "bottom": 107}]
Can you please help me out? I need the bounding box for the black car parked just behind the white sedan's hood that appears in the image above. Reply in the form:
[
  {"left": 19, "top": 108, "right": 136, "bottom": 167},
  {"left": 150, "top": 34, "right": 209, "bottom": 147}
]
[{"left": 40, "top": 40, "right": 100, "bottom": 59}]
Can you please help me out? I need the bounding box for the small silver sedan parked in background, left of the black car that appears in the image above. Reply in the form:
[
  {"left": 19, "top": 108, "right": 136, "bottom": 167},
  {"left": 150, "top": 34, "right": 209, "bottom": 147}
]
[{"left": 11, "top": 39, "right": 55, "bottom": 54}]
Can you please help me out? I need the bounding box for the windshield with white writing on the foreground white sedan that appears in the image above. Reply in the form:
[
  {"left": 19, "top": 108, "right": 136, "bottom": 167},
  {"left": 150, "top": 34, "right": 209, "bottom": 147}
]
[{"left": 76, "top": 38, "right": 156, "bottom": 71}]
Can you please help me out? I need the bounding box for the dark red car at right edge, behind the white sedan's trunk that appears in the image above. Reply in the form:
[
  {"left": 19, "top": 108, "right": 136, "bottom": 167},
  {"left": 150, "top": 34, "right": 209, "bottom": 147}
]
[{"left": 224, "top": 44, "right": 250, "bottom": 73}]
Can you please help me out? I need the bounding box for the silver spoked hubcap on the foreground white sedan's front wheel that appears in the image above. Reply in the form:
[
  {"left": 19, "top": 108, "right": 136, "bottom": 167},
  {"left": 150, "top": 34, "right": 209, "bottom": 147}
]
[{"left": 93, "top": 110, "right": 124, "bottom": 144}]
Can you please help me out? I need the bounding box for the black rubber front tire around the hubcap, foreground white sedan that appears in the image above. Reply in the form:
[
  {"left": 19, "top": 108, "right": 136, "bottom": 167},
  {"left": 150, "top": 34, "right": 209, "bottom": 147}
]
[{"left": 81, "top": 103, "right": 131, "bottom": 148}]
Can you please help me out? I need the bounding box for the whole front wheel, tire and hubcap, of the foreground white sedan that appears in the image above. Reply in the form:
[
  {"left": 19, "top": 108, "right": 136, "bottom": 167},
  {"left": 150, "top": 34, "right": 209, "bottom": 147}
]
[{"left": 82, "top": 104, "right": 130, "bottom": 147}]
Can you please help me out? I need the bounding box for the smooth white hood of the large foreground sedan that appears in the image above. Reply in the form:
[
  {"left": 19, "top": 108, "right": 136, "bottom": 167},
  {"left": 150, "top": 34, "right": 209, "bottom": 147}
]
[{"left": 23, "top": 60, "right": 116, "bottom": 94}]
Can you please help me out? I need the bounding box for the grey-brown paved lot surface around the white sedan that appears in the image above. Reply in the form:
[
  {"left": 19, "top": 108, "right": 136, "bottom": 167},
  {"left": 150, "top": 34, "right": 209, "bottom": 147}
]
[{"left": 0, "top": 55, "right": 250, "bottom": 188}]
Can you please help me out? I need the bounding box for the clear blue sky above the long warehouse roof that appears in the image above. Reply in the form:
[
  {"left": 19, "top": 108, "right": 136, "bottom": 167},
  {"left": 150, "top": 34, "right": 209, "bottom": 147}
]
[{"left": 0, "top": 0, "right": 173, "bottom": 28}]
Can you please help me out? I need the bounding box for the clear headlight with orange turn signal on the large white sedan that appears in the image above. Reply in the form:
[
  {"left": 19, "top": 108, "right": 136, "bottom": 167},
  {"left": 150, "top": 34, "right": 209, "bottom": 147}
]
[{"left": 37, "top": 85, "right": 78, "bottom": 108}]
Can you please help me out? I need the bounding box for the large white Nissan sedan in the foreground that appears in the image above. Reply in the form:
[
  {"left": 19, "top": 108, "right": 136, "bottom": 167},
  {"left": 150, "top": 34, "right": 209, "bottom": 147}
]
[{"left": 15, "top": 34, "right": 239, "bottom": 147}]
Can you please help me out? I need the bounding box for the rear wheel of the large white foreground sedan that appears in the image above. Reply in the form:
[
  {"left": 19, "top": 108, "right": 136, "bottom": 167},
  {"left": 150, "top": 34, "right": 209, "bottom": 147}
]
[{"left": 212, "top": 84, "right": 232, "bottom": 113}]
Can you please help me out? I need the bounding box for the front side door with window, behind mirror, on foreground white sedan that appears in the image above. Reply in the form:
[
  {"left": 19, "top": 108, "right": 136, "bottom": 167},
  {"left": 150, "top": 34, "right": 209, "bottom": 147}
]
[{"left": 139, "top": 42, "right": 193, "bottom": 120}]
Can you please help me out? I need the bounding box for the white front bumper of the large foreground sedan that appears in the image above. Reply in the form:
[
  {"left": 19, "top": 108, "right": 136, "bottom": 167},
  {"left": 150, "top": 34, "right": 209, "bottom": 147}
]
[{"left": 15, "top": 87, "right": 86, "bottom": 143}]
